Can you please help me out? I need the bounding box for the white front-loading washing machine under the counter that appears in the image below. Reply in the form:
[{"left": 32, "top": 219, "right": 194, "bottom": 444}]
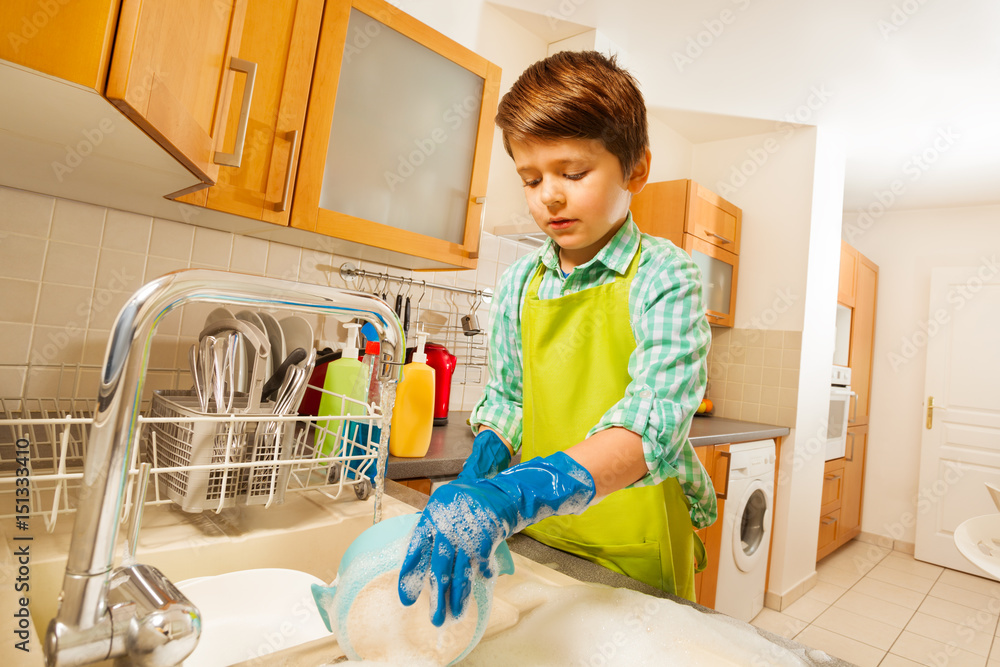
[{"left": 715, "top": 440, "right": 775, "bottom": 621}]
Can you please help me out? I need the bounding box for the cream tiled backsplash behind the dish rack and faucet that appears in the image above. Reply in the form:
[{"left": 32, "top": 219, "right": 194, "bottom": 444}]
[{"left": 0, "top": 187, "right": 530, "bottom": 410}]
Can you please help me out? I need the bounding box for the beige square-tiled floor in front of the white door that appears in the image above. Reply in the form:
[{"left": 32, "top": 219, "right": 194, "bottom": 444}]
[{"left": 752, "top": 541, "right": 1000, "bottom": 667}]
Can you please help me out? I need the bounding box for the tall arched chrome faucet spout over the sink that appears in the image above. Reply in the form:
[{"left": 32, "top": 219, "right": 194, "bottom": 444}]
[{"left": 45, "top": 269, "right": 406, "bottom": 665}]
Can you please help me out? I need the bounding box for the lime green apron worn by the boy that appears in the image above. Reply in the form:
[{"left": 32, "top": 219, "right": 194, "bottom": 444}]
[{"left": 521, "top": 244, "right": 705, "bottom": 601}]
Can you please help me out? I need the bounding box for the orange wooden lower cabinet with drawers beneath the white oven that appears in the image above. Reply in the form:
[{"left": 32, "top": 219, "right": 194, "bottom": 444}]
[{"left": 816, "top": 425, "right": 868, "bottom": 560}]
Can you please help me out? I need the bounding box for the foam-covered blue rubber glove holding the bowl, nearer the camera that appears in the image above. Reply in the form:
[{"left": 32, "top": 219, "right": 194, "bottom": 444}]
[{"left": 399, "top": 452, "right": 596, "bottom": 627}]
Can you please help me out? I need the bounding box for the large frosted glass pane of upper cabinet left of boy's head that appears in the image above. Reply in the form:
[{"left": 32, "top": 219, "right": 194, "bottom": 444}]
[{"left": 319, "top": 9, "right": 483, "bottom": 244}]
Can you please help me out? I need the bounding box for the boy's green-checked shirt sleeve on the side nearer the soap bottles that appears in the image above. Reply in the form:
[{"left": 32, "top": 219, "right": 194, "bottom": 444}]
[{"left": 469, "top": 262, "right": 525, "bottom": 452}]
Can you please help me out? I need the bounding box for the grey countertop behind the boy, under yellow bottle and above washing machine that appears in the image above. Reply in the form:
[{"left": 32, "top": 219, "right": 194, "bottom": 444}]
[{"left": 386, "top": 412, "right": 788, "bottom": 479}]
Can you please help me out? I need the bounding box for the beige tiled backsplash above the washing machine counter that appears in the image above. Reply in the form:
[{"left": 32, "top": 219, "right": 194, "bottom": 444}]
[{"left": 706, "top": 327, "right": 802, "bottom": 428}]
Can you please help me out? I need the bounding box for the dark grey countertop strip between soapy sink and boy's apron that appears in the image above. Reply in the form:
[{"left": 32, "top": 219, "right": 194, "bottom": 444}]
[{"left": 385, "top": 480, "right": 852, "bottom": 667}]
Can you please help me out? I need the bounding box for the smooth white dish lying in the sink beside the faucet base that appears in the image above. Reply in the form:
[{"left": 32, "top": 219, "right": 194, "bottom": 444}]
[{"left": 177, "top": 569, "right": 330, "bottom": 667}]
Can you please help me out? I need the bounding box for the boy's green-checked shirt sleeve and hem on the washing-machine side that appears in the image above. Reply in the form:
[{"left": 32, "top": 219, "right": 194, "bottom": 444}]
[{"left": 588, "top": 245, "right": 715, "bottom": 525}]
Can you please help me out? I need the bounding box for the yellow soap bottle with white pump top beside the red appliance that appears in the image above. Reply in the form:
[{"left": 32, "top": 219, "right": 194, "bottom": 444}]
[{"left": 389, "top": 331, "right": 434, "bottom": 458}]
